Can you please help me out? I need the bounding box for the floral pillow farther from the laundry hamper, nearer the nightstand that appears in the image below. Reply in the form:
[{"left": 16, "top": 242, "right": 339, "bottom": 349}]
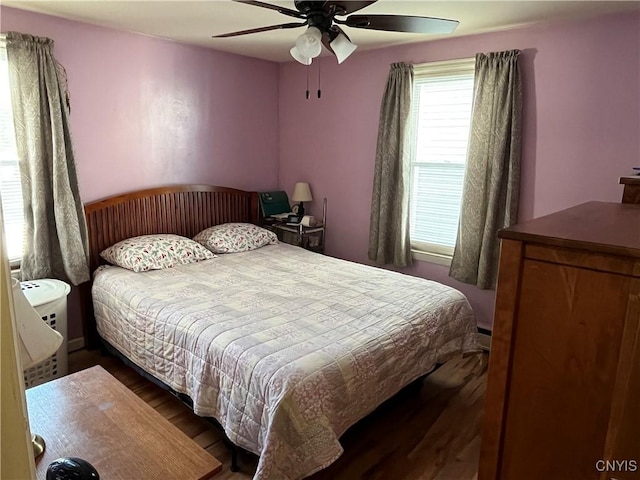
[{"left": 193, "top": 223, "right": 278, "bottom": 253}]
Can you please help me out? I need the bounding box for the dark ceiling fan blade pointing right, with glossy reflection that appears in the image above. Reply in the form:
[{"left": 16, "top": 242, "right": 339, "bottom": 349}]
[{"left": 340, "top": 15, "right": 460, "bottom": 33}]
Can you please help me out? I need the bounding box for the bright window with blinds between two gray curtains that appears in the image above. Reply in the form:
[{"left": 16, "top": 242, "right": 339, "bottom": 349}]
[{"left": 409, "top": 58, "right": 475, "bottom": 263}]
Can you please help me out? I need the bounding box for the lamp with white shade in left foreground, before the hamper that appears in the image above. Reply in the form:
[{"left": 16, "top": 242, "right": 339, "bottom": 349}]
[{"left": 12, "top": 279, "right": 63, "bottom": 458}]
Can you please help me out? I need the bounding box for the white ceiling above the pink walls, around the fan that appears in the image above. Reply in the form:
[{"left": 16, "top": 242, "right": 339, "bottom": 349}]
[{"left": 2, "top": 0, "right": 640, "bottom": 62}]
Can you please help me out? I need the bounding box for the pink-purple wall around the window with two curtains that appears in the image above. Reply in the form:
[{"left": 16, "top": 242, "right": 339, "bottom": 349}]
[{"left": 279, "top": 14, "right": 640, "bottom": 328}]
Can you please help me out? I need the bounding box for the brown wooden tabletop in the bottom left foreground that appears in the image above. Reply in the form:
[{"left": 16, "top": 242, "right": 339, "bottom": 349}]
[{"left": 26, "top": 366, "right": 222, "bottom": 480}]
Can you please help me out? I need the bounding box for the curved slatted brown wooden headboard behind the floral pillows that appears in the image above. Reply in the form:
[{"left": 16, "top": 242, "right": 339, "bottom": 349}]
[{"left": 82, "top": 185, "right": 259, "bottom": 346}]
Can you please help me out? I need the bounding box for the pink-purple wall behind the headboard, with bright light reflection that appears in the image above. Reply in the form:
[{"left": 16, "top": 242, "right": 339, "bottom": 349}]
[{"left": 0, "top": 7, "right": 278, "bottom": 339}]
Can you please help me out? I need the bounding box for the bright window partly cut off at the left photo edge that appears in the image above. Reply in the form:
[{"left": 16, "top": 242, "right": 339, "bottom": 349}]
[{"left": 0, "top": 40, "right": 24, "bottom": 264}]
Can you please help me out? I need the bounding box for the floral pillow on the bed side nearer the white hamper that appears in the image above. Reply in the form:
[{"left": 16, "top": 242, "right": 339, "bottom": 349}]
[{"left": 100, "top": 234, "right": 215, "bottom": 272}]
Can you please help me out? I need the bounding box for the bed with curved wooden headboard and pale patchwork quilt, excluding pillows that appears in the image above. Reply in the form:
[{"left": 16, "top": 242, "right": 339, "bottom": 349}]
[{"left": 85, "top": 186, "right": 478, "bottom": 480}]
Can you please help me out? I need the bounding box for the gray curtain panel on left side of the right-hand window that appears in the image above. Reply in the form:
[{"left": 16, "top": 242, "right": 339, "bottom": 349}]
[{"left": 369, "top": 63, "right": 413, "bottom": 267}]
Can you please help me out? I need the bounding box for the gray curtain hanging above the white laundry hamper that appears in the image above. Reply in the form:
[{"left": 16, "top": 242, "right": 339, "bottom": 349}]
[{"left": 7, "top": 32, "right": 89, "bottom": 285}]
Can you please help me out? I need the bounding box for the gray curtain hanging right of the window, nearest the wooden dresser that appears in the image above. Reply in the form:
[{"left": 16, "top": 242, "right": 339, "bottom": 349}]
[{"left": 449, "top": 50, "right": 522, "bottom": 289}]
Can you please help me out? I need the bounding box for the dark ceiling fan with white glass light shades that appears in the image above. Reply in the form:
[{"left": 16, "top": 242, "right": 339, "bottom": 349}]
[{"left": 213, "top": 0, "right": 459, "bottom": 65}]
